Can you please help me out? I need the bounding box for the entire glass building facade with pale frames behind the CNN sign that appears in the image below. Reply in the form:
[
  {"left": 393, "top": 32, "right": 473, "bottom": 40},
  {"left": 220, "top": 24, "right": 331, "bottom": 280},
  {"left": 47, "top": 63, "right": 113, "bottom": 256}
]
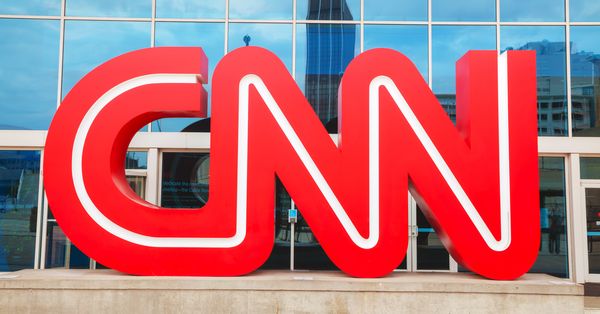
[{"left": 0, "top": 0, "right": 600, "bottom": 282}]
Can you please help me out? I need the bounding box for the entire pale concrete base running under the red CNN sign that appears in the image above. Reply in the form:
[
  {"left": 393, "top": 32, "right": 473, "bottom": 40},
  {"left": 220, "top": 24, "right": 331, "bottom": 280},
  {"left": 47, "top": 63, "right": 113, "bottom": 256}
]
[{"left": 0, "top": 269, "right": 584, "bottom": 314}]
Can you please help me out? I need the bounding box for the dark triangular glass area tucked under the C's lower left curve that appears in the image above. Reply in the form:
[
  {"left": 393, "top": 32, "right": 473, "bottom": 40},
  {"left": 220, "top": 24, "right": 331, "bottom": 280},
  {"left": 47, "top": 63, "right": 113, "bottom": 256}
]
[{"left": 46, "top": 221, "right": 90, "bottom": 269}]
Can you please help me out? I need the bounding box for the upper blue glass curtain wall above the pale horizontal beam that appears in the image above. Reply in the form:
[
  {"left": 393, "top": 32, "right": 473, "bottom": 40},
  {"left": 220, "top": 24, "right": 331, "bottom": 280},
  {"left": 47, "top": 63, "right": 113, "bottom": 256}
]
[{"left": 0, "top": 0, "right": 600, "bottom": 273}]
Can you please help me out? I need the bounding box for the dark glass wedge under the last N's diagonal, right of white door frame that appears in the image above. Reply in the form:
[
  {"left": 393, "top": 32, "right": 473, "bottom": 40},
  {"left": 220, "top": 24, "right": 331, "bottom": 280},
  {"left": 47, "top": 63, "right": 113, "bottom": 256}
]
[{"left": 417, "top": 207, "right": 450, "bottom": 270}]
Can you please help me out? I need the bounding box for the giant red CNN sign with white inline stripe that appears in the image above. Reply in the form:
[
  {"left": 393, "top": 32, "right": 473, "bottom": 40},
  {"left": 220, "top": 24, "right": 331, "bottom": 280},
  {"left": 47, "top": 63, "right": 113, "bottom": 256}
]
[{"left": 44, "top": 47, "right": 540, "bottom": 279}]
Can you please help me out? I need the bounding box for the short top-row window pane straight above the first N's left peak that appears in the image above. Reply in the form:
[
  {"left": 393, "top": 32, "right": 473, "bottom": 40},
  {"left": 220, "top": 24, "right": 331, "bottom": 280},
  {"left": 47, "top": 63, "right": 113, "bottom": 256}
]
[{"left": 229, "top": 0, "right": 293, "bottom": 20}]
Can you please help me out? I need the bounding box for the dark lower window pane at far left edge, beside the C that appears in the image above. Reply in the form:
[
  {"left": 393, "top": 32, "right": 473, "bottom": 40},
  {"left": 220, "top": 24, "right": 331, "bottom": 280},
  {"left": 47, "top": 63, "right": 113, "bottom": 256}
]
[{"left": 0, "top": 150, "right": 40, "bottom": 271}]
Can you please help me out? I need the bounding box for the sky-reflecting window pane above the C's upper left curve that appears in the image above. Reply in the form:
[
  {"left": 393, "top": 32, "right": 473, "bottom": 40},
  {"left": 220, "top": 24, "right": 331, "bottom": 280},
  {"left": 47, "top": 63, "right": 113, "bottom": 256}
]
[{"left": 62, "top": 21, "right": 150, "bottom": 98}]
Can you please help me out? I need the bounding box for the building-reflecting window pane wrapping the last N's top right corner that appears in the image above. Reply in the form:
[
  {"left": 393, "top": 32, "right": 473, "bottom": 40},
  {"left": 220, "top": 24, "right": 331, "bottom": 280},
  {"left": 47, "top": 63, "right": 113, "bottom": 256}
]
[{"left": 500, "top": 26, "right": 568, "bottom": 136}]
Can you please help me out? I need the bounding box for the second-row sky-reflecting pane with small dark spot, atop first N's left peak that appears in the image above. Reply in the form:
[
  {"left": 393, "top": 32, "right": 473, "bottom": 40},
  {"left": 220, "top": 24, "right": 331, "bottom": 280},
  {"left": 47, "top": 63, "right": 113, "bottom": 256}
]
[{"left": 228, "top": 22, "right": 292, "bottom": 72}]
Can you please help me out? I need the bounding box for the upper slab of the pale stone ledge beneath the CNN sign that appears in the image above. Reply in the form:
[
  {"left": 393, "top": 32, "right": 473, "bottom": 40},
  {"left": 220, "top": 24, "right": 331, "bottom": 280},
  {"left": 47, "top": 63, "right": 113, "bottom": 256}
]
[{"left": 0, "top": 269, "right": 584, "bottom": 295}]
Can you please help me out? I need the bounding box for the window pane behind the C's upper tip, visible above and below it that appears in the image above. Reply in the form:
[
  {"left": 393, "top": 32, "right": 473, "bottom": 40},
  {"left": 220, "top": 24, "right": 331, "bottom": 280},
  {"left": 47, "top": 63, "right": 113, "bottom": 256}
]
[{"left": 152, "top": 22, "right": 225, "bottom": 132}]
